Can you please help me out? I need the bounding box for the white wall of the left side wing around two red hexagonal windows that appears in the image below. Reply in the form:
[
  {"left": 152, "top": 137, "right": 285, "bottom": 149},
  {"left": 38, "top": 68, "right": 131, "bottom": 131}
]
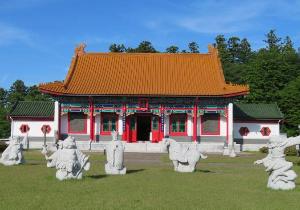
[{"left": 11, "top": 120, "right": 54, "bottom": 137}]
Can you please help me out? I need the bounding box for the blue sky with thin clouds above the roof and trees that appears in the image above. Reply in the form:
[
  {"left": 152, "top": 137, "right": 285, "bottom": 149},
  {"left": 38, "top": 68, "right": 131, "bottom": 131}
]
[{"left": 0, "top": 0, "right": 300, "bottom": 88}]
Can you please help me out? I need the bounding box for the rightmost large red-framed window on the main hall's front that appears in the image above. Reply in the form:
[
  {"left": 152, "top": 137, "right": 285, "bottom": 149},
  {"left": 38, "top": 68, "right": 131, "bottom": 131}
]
[{"left": 201, "top": 113, "right": 220, "bottom": 135}]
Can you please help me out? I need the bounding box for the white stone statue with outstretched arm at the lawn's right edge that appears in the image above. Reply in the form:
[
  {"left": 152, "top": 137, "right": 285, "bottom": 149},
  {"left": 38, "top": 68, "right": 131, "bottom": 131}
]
[{"left": 254, "top": 136, "right": 300, "bottom": 190}]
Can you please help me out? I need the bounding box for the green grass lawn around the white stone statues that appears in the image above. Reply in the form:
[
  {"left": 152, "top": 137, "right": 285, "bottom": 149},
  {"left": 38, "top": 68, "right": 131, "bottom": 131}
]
[{"left": 0, "top": 151, "right": 300, "bottom": 210}]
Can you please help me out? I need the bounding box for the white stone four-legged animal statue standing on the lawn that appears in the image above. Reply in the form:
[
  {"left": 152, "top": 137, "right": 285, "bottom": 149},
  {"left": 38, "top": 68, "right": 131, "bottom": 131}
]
[{"left": 162, "top": 138, "right": 207, "bottom": 172}]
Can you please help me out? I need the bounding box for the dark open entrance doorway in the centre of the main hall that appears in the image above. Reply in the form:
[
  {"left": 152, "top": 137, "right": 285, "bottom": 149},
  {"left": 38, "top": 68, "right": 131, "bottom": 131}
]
[{"left": 136, "top": 115, "right": 151, "bottom": 141}]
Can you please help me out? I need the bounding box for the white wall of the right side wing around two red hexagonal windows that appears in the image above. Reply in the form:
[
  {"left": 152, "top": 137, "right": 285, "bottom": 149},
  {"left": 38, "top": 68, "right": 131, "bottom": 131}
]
[{"left": 233, "top": 122, "right": 280, "bottom": 139}]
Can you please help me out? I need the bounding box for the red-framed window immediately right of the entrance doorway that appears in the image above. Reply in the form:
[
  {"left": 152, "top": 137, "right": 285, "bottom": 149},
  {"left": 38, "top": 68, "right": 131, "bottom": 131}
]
[{"left": 170, "top": 114, "right": 187, "bottom": 136}]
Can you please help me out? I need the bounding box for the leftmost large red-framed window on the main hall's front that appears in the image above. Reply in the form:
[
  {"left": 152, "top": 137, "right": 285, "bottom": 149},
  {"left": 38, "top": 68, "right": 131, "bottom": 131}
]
[{"left": 68, "top": 112, "right": 87, "bottom": 133}]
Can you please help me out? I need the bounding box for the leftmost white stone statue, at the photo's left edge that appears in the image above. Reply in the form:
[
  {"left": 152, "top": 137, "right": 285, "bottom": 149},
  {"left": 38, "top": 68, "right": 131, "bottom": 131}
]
[{"left": 0, "top": 137, "right": 25, "bottom": 166}]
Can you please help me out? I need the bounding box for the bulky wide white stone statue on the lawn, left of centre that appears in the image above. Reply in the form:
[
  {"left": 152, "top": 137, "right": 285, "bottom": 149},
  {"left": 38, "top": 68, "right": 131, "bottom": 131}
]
[{"left": 42, "top": 136, "right": 91, "bottom": 180}]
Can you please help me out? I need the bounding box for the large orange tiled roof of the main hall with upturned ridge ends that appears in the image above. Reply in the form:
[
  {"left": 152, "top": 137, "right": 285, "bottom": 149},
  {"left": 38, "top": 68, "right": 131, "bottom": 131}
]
[{"left": 39, "top": 46, "right": 249, "bottom": 96}]
